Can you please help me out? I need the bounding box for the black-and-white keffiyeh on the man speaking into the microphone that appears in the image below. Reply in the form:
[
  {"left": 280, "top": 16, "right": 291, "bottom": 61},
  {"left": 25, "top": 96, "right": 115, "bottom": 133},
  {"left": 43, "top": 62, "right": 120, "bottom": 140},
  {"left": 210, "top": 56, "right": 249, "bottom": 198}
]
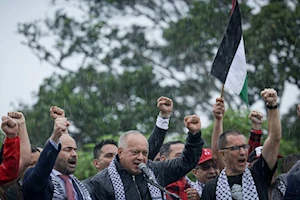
[{"left": 108, "top": 157, "right": 164, "bottom": 200}]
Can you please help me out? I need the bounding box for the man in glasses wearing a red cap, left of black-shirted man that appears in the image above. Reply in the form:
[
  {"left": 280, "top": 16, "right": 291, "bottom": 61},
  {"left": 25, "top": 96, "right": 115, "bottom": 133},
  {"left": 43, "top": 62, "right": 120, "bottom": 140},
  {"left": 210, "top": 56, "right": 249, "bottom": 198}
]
[{"left": 186, "top": 148, "right": 220, "bottom": 200}]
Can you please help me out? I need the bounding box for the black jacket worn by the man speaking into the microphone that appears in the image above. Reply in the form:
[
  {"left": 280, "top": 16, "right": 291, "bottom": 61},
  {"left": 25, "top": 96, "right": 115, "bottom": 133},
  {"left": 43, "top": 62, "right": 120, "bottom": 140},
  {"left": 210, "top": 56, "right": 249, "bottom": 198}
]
[{"left": 88, "top": 133, "right": 203, "bottom": 200}]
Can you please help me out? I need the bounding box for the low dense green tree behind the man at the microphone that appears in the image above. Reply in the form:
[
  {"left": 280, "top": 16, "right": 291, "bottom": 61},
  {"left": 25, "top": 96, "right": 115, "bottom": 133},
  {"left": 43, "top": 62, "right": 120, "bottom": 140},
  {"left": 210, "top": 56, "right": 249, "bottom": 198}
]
[{"left": 20, "top": 67, "right": 190, "bottom": 147}]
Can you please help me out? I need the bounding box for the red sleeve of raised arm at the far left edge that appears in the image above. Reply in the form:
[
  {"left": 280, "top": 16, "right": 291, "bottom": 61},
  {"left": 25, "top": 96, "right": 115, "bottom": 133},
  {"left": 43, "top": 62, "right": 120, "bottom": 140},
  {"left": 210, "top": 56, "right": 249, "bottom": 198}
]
[{"left": 0, "top": 136, "right": 20, "bottom": 185}]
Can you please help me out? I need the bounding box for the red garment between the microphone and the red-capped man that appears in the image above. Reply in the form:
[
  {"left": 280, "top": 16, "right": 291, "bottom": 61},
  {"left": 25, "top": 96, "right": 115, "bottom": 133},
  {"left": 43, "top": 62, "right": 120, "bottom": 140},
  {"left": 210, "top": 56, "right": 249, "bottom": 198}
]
[{"left": 166, "top": 177, "right": 190, "bottom": 200}]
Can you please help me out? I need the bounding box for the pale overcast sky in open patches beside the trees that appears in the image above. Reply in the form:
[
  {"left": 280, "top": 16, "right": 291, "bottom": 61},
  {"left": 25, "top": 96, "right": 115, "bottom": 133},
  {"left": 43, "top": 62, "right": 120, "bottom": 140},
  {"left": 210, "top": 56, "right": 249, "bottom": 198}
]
[{"left": 0, "top": 0, "right": 300, "bottom": 119}]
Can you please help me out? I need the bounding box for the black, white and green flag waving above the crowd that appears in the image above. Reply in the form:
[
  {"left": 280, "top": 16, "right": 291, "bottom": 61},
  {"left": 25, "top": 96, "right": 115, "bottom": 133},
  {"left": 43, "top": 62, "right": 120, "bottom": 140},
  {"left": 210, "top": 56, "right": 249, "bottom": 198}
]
[{"left": 211, "top": 1, "right": 248, "bottom": 104}]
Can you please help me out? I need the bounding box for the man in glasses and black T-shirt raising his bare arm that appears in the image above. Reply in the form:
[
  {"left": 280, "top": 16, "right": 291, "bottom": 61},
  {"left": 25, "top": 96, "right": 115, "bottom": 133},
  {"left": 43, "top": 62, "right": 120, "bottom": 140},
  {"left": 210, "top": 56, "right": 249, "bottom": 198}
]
[{"left": 202, "top": 89, "right": 281, "bottom": 200}]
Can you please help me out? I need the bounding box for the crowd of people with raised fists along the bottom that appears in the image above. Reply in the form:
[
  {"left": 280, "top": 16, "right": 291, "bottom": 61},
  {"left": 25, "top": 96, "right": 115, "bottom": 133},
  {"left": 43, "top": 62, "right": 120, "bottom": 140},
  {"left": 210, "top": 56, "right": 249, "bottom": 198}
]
[{"left": 0, "top": 88, "right": 300, "bottom": 200}]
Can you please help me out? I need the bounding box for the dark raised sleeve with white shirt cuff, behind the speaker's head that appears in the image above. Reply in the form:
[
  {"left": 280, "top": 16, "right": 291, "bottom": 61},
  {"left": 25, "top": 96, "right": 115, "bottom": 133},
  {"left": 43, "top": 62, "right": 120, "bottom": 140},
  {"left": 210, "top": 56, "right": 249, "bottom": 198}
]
[{"left": 148, "top": 126, "right": 167, "bottom": 160}]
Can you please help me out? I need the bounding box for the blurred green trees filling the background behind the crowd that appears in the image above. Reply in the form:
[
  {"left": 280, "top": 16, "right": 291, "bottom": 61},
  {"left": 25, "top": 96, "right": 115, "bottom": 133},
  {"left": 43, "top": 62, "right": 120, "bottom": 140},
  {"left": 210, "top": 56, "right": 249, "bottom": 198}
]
[{"left": 2, "top": 0, "right": 300, "bottom": 178}]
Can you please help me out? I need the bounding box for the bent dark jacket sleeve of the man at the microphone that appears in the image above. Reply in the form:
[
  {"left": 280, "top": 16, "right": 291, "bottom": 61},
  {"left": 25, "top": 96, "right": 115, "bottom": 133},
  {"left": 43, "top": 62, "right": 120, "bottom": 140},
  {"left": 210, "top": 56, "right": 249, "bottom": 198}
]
[{"left": 148, "top": 132, "right": 203, "bottom": 187}]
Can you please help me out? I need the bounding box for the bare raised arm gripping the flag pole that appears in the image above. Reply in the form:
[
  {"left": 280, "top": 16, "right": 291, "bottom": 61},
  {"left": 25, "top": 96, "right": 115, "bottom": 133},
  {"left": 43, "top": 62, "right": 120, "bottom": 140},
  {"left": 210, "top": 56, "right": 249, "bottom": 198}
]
[{"left": 211, "top": 98, "right": 225, "bottom": 170}]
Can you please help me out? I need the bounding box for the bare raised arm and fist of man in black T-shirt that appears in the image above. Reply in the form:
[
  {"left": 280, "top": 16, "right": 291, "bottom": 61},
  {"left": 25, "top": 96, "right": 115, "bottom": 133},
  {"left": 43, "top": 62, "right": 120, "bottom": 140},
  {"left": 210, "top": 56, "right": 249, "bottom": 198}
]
[{"left": 261, "top": 89, "right": 282, "bottom": 169}]
